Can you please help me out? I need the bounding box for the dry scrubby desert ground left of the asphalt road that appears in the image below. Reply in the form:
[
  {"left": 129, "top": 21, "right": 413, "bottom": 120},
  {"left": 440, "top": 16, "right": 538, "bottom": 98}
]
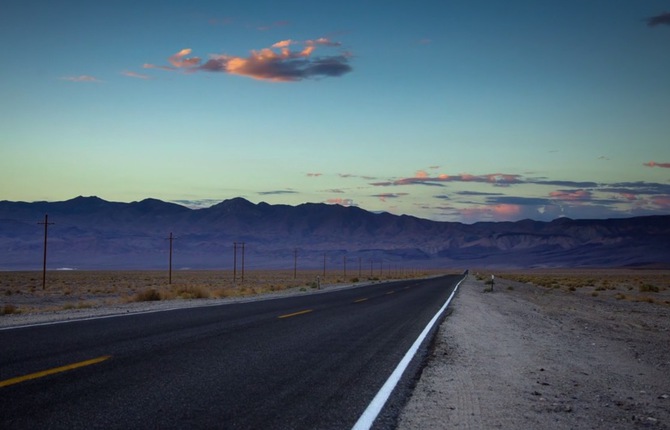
[{"left": 0, "top": 268, "right": 439, "bottom": 320}]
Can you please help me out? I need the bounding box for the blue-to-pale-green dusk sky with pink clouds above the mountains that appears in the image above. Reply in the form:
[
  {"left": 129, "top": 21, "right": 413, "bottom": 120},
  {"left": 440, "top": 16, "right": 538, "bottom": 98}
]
[{"left": 0, "top": 0, "right": 670, "bottom": 223}]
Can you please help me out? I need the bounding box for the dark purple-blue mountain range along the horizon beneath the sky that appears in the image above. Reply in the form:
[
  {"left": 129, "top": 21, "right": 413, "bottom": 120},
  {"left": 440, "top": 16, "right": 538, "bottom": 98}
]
[{"left": 0, "top": 197, "right": 670, "bottom": 270}]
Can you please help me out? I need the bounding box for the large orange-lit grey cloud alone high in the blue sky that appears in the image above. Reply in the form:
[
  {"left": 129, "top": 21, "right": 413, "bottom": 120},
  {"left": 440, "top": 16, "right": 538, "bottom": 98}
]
[{"left": 143, "top": 38, "right": 352, "bottom": 82}]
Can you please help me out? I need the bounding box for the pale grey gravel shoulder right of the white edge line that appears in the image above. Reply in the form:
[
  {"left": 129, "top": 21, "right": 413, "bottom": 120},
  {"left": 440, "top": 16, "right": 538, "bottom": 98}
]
[{"left": 398, "top": 277, "right": 670, "bottom": 430}]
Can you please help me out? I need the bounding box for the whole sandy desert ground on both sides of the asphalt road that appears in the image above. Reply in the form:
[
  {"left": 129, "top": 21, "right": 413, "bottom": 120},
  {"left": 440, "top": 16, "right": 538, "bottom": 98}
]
[{"left": 0, "top": 269, "right": 670, "bottom": 430}]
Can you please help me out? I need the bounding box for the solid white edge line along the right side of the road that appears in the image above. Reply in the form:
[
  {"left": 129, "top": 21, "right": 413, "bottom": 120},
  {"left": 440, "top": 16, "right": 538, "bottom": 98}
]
[{"left": 352, "top": 277, "right": 465, "bottom": 430}]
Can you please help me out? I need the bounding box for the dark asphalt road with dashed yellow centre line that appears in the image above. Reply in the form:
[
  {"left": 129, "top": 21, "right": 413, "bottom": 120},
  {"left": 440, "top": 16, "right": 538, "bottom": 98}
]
[{"left": 0, "top": 276, "right": 461, "bottom": 429}]
